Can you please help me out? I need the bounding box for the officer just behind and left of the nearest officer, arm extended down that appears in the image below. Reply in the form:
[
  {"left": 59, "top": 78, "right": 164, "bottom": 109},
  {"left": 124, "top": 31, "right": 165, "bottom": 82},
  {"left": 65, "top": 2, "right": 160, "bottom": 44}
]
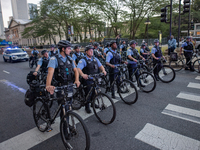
[{"left": 33, "top": 50, "right": 50, "bottom": 76}]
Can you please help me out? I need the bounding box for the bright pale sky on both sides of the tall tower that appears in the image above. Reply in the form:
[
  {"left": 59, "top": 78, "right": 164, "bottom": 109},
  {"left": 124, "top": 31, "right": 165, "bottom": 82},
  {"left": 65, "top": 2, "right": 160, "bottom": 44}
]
[{"left": 0, "top": 0, "right": 41, "bottom": 28}]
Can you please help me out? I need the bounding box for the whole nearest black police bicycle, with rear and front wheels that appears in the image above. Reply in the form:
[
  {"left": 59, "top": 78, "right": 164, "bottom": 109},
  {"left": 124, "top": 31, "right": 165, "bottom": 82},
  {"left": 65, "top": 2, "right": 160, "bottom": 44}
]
[{"left": 33, "top": 84, "right": 90, "bottom": 150}]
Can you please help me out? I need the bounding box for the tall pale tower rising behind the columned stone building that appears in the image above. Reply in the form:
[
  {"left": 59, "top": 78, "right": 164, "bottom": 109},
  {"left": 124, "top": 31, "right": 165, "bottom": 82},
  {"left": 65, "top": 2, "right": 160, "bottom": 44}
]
[{"left": 11, "top": 0, "right": 28, "bottom": 19}]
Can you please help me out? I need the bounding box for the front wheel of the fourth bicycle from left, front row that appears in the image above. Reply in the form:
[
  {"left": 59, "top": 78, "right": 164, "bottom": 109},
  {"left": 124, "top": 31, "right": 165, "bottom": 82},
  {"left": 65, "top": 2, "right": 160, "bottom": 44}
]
[{"left": 137, "top": 72, "right": 156, "bottom": 93}]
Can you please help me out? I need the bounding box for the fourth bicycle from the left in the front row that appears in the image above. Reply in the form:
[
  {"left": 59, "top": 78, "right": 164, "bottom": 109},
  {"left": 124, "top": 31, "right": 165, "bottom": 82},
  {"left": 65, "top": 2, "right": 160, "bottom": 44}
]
[{"left": 129, "top": 60, "right": 156, "bottom": 93}]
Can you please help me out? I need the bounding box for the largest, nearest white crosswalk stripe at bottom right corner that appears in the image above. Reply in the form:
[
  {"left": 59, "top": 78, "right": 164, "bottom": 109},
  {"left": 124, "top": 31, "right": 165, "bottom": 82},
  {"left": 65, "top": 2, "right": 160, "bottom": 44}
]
[{"left": 135, "top": 123, "right": 200, "bottom": 150}]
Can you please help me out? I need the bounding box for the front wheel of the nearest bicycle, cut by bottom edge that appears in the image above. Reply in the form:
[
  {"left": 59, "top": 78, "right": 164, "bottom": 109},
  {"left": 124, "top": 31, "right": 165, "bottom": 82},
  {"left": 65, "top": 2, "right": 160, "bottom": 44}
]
[{"left": 60, "top": 111, "right": 90, "bottom": 150}]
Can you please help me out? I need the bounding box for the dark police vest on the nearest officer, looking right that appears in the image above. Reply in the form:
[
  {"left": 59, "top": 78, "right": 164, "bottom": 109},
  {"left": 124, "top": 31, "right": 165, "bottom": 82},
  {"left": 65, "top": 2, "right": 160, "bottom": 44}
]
[{"left": 54, "top": 55, "right": 74, "bottom": 85}]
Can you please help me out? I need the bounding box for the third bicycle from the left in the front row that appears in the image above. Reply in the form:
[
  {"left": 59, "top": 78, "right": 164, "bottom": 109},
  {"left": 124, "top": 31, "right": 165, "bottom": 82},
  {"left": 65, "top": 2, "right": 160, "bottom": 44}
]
[{"left": 102, "top": 64, "right": 138, "bottom": 105}]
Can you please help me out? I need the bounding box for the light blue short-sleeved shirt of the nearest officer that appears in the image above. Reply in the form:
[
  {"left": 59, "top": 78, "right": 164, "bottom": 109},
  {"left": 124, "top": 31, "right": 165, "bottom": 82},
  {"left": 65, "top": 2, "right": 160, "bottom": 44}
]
[{"left": 47, "top": 54, "right": 76, "bottom": 69}]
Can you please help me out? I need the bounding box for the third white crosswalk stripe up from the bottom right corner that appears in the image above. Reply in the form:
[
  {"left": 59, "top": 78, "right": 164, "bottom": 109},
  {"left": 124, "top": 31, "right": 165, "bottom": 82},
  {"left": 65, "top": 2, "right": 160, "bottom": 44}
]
[{"left": 176, "top": 92, "right": 200, "bottom": 102}]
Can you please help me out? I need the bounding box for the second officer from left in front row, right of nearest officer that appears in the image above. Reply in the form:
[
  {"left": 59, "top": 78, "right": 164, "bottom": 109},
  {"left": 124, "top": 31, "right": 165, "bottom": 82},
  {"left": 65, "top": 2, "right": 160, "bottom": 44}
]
[{"left": 77, "top": 45, "right": 106, "bottom": 113}]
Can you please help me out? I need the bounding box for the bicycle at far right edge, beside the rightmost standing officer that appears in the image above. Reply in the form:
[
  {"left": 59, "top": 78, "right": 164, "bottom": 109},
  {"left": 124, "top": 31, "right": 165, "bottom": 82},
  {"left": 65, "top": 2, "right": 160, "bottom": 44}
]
[{"left": 169, "top": 50, "right": 200, "bottom": 73}]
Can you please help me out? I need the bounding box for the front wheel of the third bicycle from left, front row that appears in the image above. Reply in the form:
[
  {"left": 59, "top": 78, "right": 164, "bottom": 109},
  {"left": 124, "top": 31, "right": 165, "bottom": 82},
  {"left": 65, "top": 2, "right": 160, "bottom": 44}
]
[{"left": 118, "top": 80, "right": 138, "bottom": 105}]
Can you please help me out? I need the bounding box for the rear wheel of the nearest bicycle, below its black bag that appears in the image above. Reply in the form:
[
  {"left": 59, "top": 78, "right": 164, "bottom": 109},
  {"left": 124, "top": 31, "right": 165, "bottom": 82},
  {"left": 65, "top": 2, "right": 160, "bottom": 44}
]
[{"left": 33, "top": 100, "right": 48, "bottom": 132}]
